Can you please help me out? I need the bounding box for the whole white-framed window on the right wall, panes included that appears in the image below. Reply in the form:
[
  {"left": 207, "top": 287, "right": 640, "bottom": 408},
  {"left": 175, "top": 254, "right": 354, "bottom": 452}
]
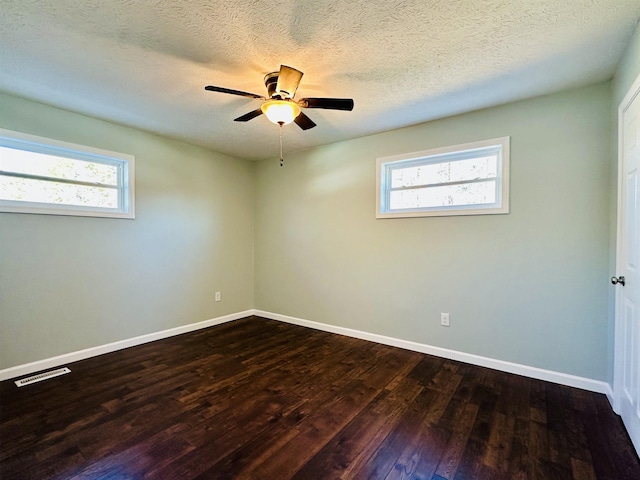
[{"left": 376, "top": 137, "right": 509, "bottom": 218}]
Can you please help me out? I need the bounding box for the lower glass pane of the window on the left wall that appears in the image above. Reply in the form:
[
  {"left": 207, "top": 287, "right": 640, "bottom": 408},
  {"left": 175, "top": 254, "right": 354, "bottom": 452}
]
[{"left": 0, "top": 176, "right": 118, "bottom": 208}]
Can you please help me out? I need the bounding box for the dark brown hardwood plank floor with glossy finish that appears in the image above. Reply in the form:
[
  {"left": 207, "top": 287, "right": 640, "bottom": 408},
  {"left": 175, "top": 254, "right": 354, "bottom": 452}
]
[{"left": 0, "top": 317, "right": 640, "bottom": 480}]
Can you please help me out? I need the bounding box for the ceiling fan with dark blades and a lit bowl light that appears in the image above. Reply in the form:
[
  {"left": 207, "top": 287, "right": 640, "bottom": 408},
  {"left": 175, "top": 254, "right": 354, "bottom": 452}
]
[{"left": 204, "top": 65, "right": 353, "bottom": 130}]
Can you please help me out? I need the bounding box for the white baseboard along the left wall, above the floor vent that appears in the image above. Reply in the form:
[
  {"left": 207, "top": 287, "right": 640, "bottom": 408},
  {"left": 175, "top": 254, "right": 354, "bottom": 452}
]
[{"left": 0, "top": 310, "right": 254, "bottom": 381}]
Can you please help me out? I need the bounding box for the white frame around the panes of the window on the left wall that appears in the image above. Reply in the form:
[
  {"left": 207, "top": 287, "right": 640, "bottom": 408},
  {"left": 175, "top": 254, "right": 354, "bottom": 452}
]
[{"left": 0, "top": 128, "right": 135, "bottom": 219}]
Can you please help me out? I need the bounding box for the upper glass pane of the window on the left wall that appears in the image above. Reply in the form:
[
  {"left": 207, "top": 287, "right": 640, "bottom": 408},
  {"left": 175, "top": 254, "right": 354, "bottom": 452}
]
[{"left": 0, "top": 147, "right": 118, "bottom": 186}]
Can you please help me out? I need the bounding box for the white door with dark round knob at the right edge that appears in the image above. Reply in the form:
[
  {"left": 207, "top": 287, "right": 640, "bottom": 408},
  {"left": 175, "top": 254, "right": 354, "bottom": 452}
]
[{"left": 611, "top": 73, "right": 640, "bottom": 453}]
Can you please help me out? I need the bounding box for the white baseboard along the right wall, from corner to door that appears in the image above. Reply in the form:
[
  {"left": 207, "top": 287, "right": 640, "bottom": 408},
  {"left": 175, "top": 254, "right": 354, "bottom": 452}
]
[{"left": 252, "top": 310, "right": 613, "bottom": 405}]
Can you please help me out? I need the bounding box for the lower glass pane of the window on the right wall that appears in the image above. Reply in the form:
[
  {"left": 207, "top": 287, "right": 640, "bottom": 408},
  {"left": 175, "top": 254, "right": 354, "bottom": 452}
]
[{"left": 389, "top": 180, "right": 496, "bottom": 210}]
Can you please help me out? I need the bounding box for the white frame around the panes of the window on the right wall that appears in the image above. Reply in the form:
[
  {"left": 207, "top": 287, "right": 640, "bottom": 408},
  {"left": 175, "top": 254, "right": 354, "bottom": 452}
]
[{"left": 376, "top": 137, "right": 510, "bottom": 218}]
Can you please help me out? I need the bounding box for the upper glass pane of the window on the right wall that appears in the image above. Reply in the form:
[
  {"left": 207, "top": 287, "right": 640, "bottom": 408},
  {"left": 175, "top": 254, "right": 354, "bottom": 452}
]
[{"left": 391, "top": 154, "right": 498, "bottom": 188}]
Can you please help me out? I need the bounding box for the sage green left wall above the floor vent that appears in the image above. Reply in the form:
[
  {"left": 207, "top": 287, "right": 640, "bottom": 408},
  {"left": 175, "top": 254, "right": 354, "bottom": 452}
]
[{"left": 0, "top": 94, "right": 254, "bottom": 368}]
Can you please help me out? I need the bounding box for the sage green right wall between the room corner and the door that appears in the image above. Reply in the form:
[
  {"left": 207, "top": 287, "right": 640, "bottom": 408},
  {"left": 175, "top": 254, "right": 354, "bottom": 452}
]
[{"left": 255, "top": 82, "right": 611, "bottom": 380}]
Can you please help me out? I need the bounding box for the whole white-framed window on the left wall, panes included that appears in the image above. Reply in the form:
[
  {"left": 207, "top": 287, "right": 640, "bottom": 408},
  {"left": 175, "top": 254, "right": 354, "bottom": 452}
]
[{"left": 0, "top": 129, "right": 135, "bottom": 218}]
